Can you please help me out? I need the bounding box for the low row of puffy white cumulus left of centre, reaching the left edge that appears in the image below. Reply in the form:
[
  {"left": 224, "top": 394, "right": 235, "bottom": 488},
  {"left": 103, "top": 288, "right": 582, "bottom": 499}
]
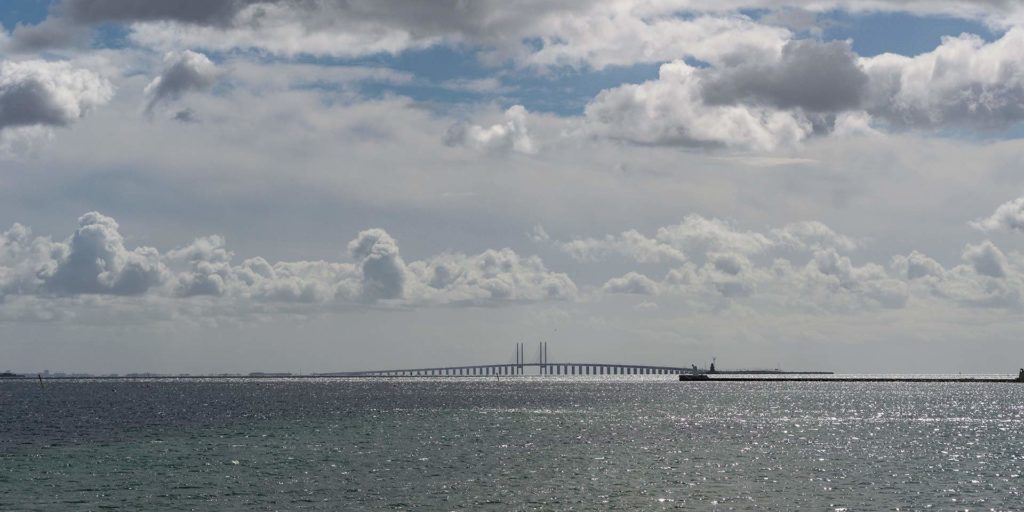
[{"left": 0, "top": 208, "right": 578, "bottom": 310}]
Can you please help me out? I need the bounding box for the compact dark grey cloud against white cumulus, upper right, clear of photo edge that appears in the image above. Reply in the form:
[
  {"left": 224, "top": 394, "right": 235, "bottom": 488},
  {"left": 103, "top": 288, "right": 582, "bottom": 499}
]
[{"left": 701, "top": 39, "right": 868, "bottom": 113}]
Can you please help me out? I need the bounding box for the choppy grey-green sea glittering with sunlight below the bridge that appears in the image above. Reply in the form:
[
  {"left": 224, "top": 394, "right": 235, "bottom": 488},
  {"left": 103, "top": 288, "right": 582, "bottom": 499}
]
[{"left": 0, "top": 376, "right": 1024, "bottom": 511}]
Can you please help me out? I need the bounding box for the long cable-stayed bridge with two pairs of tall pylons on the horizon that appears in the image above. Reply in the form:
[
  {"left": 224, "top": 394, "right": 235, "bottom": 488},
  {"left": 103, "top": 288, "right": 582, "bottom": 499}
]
[{"left": 316, "top": 342, "right": 707, "bottom": 377}]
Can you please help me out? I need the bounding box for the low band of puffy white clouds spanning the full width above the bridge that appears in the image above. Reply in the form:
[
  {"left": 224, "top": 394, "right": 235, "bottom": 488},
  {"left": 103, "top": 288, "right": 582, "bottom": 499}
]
[{"left": 0, "top": 198, "right": 1024, "bottom": 321}]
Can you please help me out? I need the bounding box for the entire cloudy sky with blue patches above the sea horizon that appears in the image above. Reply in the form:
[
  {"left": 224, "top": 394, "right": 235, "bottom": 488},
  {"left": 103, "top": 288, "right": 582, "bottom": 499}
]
[{"left": 0, "top": 0, "right": 1024, "bottom": 374}]
